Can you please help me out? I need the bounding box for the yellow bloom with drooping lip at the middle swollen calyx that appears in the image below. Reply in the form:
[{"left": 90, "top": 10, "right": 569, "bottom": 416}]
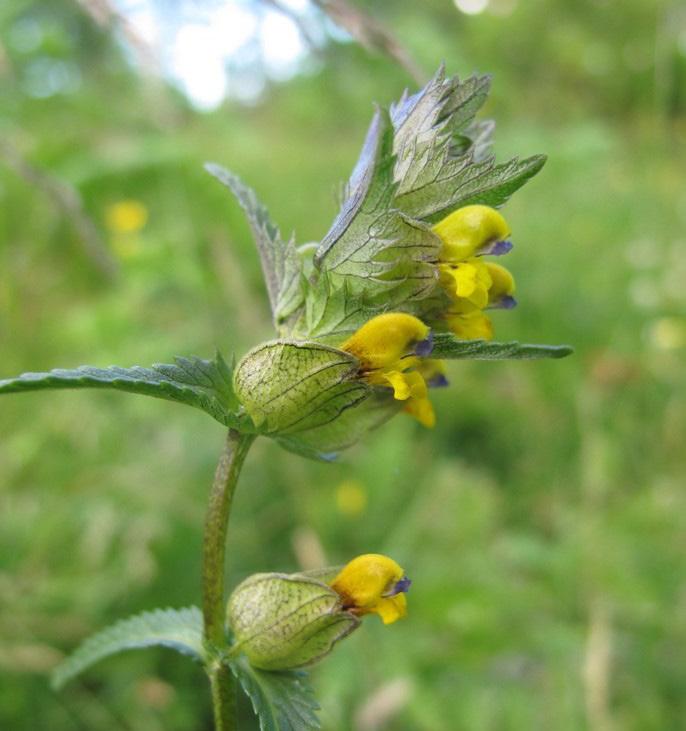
[{"left": 341, "top": 312, "right": 444, "bottom": 427}]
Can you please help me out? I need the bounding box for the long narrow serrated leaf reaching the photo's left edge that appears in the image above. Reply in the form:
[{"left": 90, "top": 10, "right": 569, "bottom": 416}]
[{"left": 0, "top": 353, "right": 245, "bottom": 429}]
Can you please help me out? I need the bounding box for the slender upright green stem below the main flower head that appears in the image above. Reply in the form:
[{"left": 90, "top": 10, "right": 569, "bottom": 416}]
[{"left": 202, "top": 429, "right": 255, "bottom": 731}]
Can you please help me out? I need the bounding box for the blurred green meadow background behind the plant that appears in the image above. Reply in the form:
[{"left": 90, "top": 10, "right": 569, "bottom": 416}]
[{"left": 0, "top": 0, "right": 686, "bottom": 731}]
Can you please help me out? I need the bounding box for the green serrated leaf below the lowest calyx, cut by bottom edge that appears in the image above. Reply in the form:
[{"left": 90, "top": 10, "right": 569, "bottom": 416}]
[{"left": 229, "top": 656, "right": 321, "bottom": 731}]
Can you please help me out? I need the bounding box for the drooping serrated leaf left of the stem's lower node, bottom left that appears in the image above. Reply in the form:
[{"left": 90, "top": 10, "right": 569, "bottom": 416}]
[{"left": 51, "top": 607, "right": 205, "bottom": 690}]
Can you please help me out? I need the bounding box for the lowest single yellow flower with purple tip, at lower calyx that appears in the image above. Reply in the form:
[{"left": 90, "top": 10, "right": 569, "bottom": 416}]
[{"left": 331, "top": 553, "right": 411, "bottom": 624}]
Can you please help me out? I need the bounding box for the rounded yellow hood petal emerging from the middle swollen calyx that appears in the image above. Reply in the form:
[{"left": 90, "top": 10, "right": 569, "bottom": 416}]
[{"left": 340, "top": 312, "right": 429, "bottom": 370}]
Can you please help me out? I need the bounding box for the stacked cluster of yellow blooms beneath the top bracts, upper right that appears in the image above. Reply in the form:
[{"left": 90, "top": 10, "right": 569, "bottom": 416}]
[{"left": 433, "top": 205, "right": 516, "bottom": 340}]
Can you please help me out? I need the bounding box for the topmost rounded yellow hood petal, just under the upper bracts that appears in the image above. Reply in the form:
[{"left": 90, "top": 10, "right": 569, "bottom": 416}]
[{"left": 433, "top": 205, "right": 510, "bottom": 262}]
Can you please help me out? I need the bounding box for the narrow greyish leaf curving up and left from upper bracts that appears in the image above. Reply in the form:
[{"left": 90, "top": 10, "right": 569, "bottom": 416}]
[{"left": 205, "top": 163, "right": 304, "bottom": 327}]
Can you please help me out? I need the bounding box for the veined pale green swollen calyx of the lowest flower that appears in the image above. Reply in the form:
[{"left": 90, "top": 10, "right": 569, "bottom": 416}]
[{"left": 227, "top": 574, "right": 360, "bottom": 670}]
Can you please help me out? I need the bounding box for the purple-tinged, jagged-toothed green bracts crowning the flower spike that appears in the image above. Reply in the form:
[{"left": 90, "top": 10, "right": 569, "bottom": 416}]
[{"left": 207, "top": 68, "right": 545, "bottom": 344}]
